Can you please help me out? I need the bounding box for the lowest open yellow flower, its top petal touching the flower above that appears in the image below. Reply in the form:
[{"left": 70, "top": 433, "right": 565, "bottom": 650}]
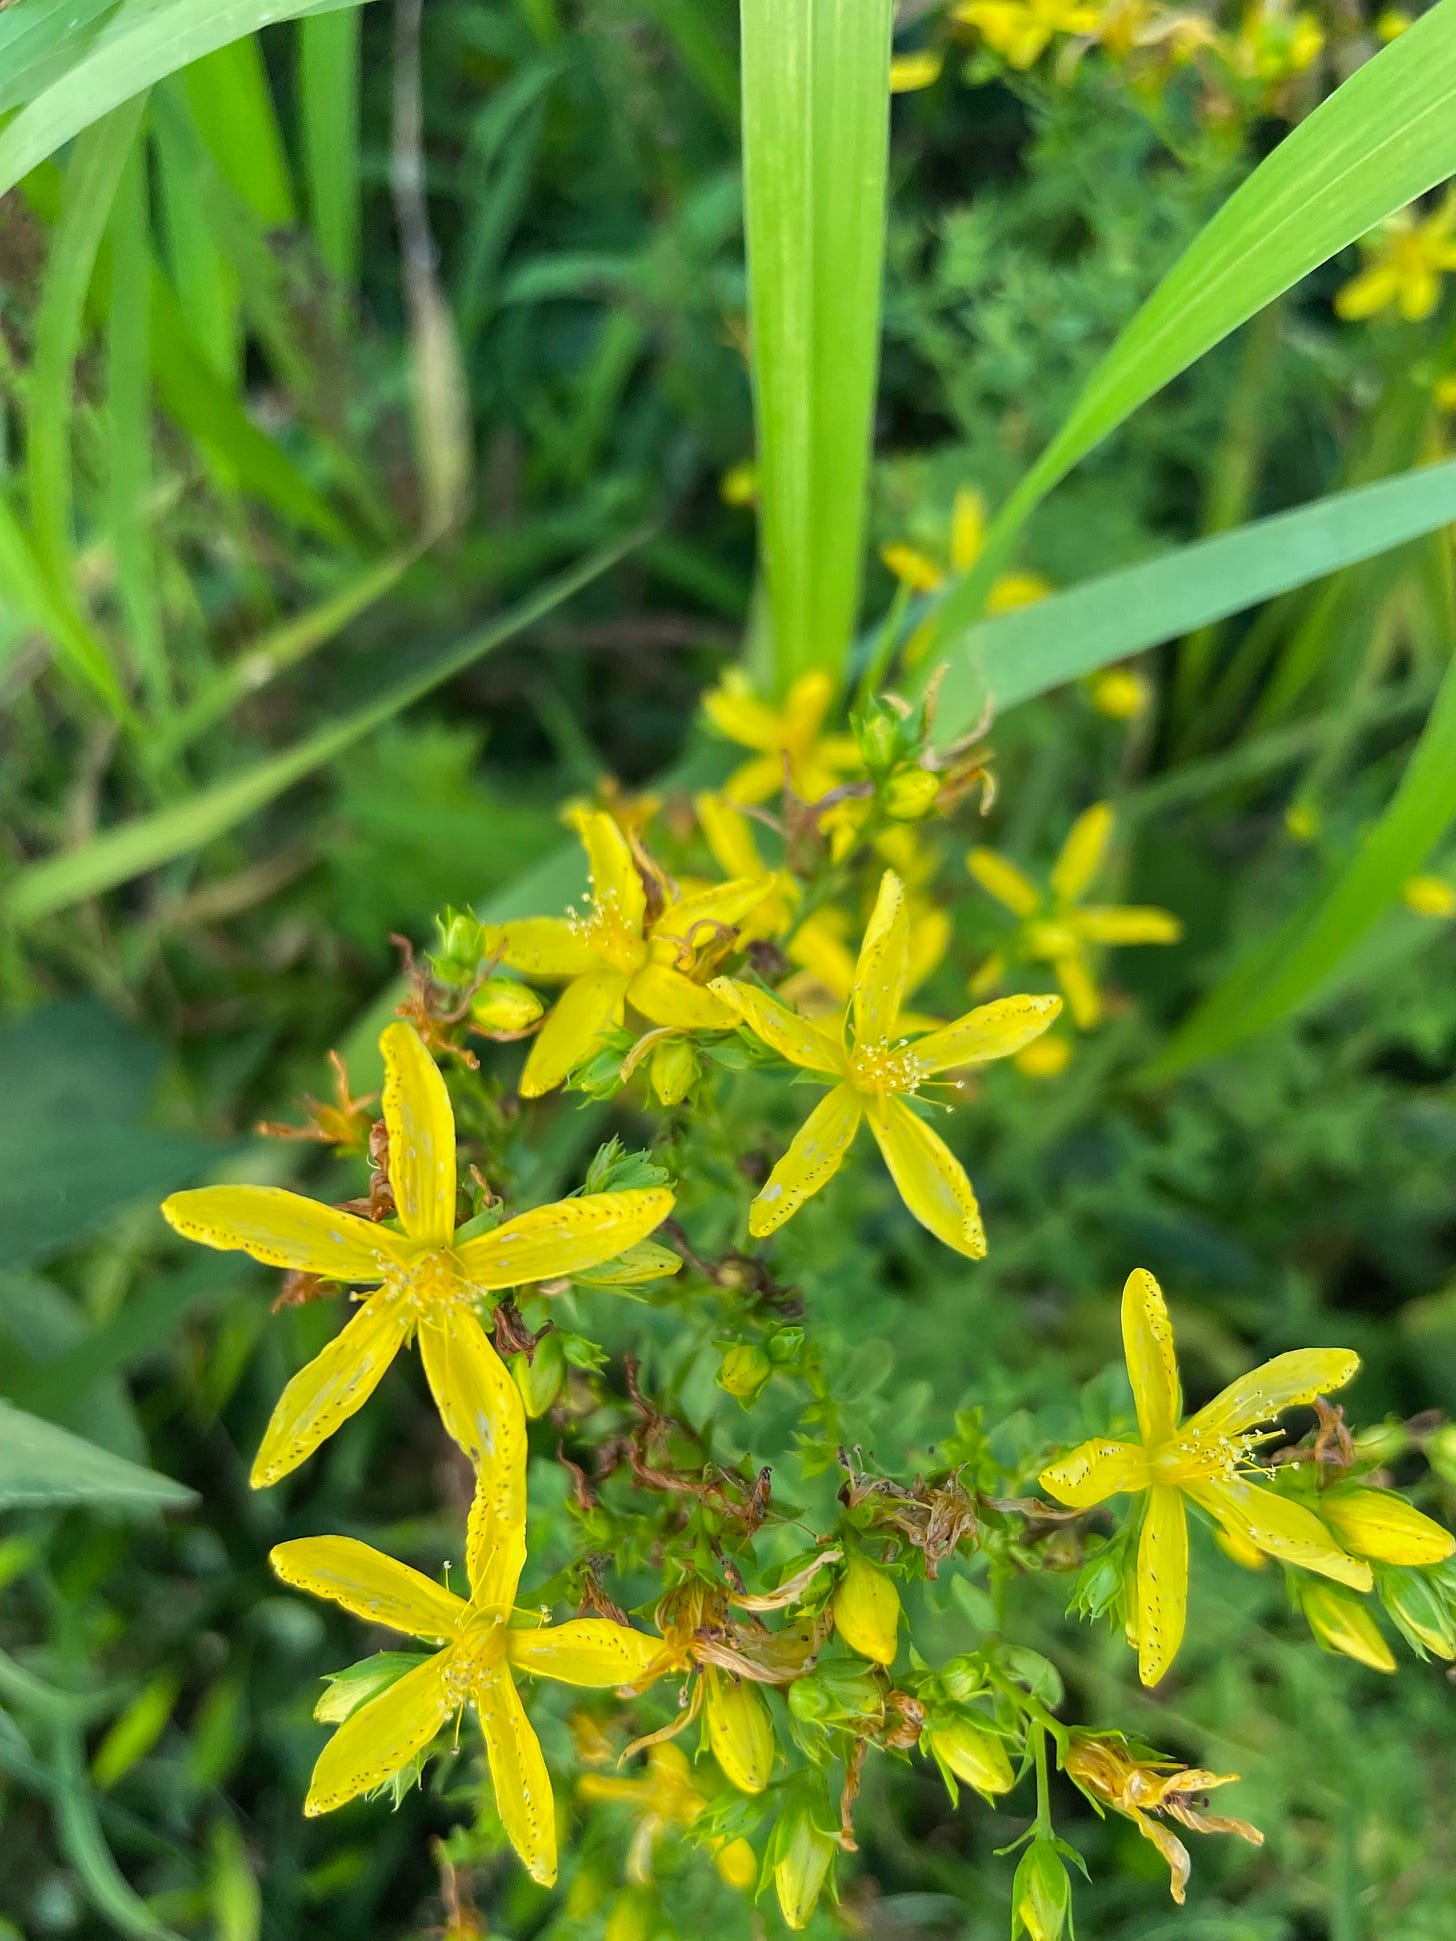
[{"left": 270, "top": 1467, "right": 662, "bottom": 1887}]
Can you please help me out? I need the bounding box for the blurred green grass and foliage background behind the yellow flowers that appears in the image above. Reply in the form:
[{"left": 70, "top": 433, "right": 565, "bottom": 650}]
[{"left": 0, "top": 0, "right": 1456, "bottom": 1941}]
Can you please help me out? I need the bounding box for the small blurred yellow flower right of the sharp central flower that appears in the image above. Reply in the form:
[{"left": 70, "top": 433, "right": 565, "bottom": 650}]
[{"left": 965, "top": 802, "right": 1182, "bottom": 1031}]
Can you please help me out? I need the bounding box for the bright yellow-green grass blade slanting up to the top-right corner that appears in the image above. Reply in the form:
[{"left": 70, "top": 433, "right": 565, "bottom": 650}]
[{"left": 940, "top": 0, "right": 1456, "bottom": 639}]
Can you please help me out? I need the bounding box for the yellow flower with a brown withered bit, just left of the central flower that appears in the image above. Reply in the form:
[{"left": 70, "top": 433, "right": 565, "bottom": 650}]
[{"left": 481, "top": 809, "right": 771, "bottom": 1099}]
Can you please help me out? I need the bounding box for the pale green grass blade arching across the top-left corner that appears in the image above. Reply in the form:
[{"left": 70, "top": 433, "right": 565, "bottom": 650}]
[{"left": 0, "top": 0, "right": 378, "bottom": 196}]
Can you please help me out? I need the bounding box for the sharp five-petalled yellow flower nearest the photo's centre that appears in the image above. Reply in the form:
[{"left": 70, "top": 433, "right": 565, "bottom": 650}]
[{"left": 712, "top": 870, "right": 1062, "bottom": 1260}]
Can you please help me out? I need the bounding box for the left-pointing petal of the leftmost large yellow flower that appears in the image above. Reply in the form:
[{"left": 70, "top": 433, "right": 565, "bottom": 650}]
[{"left": 161, "top": 1186, "right": 410, "bottom": 1281}]
